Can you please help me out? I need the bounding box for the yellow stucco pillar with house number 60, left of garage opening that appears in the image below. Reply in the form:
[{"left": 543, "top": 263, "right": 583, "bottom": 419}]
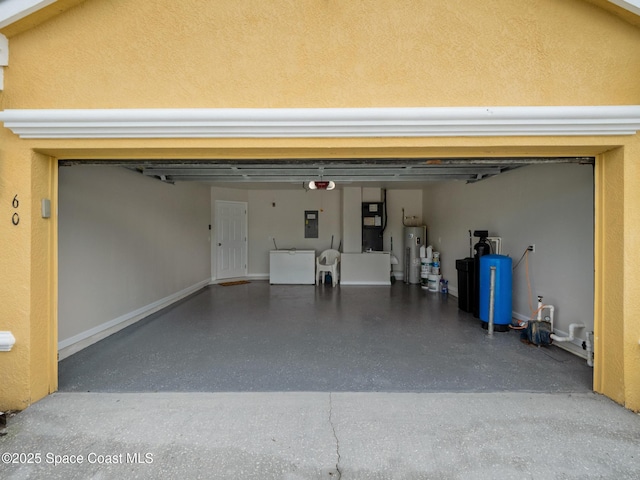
[{"left": 0, "top": 138, "right": 57, "bottom": 410}]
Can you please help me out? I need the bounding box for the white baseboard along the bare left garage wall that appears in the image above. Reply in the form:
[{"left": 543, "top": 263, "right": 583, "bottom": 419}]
[{"left": 58, "top": 279, "right": 211, "bottom": 360}]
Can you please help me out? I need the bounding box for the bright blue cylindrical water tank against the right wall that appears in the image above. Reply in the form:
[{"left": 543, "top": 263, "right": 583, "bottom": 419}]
[{"left": 480, "top": 255, "right": 512, "bottom": 332}]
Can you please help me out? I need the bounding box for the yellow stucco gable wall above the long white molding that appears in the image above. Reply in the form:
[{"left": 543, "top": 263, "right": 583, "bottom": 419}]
[{"left": 3, "top": 0, "right": 640, "bottom": 108}]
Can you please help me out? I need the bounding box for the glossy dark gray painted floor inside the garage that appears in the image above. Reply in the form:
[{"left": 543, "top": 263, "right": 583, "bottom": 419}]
[{"left": 59, "top": 281, "right": 593, "bottom": 392}]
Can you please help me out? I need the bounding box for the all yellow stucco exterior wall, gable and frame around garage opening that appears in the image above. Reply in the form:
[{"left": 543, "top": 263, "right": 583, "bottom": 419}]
[{"left": 0, "top": 0, "right": 640, "bottom": 410}]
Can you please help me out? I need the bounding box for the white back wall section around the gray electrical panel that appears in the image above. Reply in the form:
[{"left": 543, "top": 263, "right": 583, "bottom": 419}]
[{"left": 247, "top": 187, "right": 342, "bottom": 278}]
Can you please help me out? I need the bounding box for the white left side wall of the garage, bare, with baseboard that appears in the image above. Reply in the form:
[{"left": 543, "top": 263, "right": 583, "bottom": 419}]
[{"left": 58, "top": 166, "right": 211, "bottom": 358}]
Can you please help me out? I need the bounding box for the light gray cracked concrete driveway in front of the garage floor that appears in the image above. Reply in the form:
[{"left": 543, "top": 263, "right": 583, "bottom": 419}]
[{"left": 0, "top": 392, "right": 640, "bottom": 480}]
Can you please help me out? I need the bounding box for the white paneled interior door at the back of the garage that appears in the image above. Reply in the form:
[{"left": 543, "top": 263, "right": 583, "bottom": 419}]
[{"left": 216, "top": 201, "right": 247, "bottom": 279}]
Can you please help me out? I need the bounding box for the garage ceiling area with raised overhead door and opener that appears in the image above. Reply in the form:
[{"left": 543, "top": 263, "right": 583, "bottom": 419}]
[{"left": 60, "top": 157, "right": 594, "bottom": 188}]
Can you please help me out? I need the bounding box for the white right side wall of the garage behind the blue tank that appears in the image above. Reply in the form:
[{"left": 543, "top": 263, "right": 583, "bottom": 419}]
[{"left": 424, "top": 164, "right": 594, "bottom": 353}]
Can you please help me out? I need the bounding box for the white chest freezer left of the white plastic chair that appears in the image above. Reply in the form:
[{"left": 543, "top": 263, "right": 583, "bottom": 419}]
[{"left": 269, "top": 250, "right": 316, "bottom": 285}]
